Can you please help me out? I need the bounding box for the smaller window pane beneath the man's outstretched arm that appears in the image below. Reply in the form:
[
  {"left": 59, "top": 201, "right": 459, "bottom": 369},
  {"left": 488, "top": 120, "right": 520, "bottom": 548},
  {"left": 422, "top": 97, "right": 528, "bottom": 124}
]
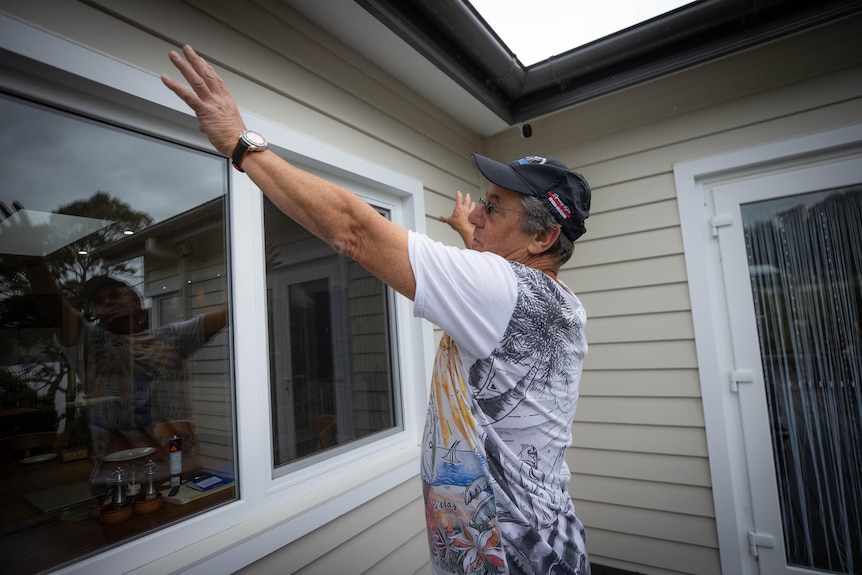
[{"left": 264, "top": 199, "right": 398, "bottom": 467}]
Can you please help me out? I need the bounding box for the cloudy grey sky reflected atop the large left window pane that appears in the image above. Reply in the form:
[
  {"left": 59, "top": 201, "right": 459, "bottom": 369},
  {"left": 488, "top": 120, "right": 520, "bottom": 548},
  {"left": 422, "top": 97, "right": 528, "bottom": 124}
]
[{"left": 0, "top": 95, "right": 226, "bottom": 223}]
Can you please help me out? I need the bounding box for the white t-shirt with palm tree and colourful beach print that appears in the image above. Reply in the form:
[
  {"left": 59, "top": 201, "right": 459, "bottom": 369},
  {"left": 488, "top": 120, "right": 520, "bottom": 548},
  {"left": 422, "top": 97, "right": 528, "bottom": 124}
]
[{"left": 410, "top": 233, "right": 589, "bottom": 575}]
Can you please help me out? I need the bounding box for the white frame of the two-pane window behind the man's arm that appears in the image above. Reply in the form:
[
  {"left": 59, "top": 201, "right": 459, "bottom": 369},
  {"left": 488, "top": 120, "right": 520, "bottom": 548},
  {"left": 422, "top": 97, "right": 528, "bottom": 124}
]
[{"left": 0, "top": 14, "right": 434, "bottom": 574}]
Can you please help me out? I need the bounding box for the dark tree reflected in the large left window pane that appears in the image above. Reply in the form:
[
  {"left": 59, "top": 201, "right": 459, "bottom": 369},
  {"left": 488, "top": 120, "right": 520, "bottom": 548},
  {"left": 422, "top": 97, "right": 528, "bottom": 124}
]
[{"left": 0, "top": 191, "right": 152, "bottom": 445}]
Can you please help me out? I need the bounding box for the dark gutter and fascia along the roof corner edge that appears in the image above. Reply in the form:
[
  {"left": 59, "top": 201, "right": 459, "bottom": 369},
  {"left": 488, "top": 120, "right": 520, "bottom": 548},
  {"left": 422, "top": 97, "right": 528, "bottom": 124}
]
[{"left": 355, "top": 0, "right": 862, "bottom": 124}]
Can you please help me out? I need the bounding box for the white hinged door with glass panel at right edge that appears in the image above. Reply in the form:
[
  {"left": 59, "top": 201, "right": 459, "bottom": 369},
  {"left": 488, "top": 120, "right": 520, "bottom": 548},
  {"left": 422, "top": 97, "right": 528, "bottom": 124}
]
[{"left": 706, "top": 154, "right": 862, "bottom": 575}]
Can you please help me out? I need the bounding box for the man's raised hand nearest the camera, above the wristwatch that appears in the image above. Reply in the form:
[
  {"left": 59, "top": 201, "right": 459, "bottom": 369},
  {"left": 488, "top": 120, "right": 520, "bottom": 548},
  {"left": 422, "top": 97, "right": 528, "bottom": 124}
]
[{"left": 162, "top": 45, "right": 245, "bottom": 157}]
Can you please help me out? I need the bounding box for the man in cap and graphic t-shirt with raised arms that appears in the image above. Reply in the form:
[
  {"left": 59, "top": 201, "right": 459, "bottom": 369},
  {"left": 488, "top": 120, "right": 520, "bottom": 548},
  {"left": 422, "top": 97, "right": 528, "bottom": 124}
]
[{"left": 162, "top": 46, "right": 590, "bottom": 574}]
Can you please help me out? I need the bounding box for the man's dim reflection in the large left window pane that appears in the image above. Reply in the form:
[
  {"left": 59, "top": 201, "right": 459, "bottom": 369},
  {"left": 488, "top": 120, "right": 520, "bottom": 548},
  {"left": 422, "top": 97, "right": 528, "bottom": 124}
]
[{"left": 71, "top": 276, "right": 227, "bottom": 468}]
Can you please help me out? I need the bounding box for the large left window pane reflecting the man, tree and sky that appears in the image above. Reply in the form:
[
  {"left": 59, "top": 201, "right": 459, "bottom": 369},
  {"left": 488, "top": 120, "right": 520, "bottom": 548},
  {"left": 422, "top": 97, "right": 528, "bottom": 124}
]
[{"left": 0, "top": 94, "right": 236, "bottom": 573}]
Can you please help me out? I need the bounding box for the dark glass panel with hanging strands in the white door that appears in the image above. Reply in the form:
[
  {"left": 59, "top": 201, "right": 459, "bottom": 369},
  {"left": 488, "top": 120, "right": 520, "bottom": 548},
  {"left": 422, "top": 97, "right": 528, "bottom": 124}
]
[{"left": 742, "top": 186, "right": 862, "bottom": 575}]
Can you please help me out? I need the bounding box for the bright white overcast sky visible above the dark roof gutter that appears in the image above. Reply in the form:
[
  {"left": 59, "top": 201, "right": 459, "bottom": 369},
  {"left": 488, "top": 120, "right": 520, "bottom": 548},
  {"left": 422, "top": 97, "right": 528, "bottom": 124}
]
[{"left": 469, "top": 0, "right": 693, "bottom": 66}]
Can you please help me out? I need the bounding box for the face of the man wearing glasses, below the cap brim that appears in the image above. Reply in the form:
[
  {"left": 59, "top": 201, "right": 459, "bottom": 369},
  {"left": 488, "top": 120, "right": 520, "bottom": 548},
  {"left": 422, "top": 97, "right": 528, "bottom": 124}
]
[{"left": 467, "top": 184, "right": 533, "bottom": 263}]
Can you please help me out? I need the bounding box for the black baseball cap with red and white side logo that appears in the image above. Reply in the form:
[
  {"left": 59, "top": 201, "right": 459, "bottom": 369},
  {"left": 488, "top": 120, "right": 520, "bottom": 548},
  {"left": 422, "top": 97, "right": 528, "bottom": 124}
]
[{"left": 471, "top": 154, "right": 591, "bottom": 241}]
